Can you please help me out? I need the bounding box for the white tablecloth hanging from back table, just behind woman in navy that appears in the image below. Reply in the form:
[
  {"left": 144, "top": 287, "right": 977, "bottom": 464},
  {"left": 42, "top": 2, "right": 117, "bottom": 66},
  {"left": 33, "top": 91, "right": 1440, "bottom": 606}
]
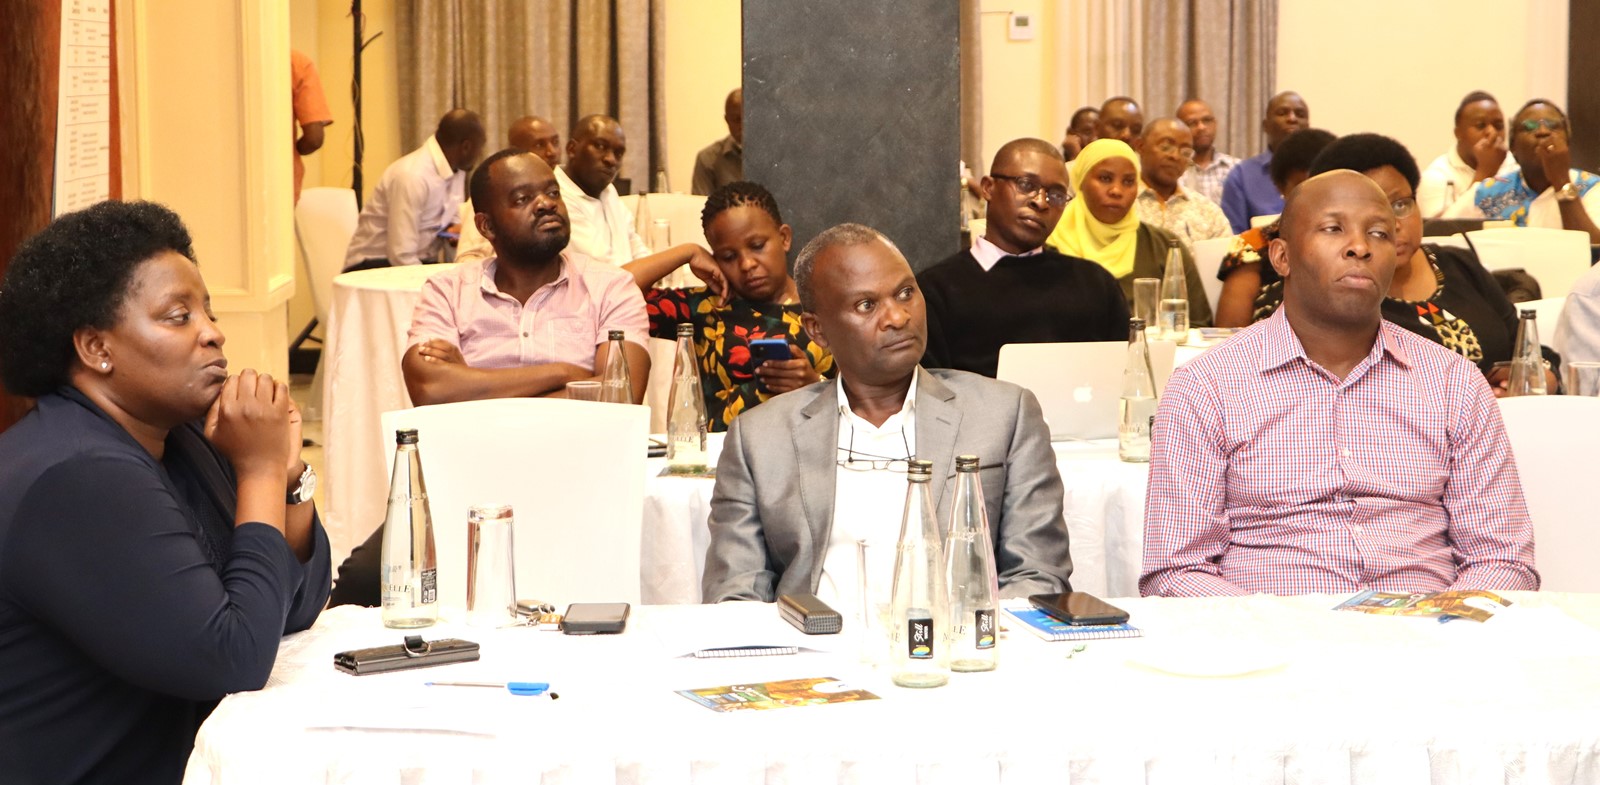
[{"left": 318, "top": 264, "right": 454, "bottom": 564}]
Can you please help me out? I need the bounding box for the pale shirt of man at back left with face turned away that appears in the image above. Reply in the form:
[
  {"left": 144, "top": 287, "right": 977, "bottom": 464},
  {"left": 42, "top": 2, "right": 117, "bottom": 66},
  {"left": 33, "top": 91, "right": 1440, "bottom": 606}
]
[{"left": 344, "top": 136, "right": 467, "bottom": 267}]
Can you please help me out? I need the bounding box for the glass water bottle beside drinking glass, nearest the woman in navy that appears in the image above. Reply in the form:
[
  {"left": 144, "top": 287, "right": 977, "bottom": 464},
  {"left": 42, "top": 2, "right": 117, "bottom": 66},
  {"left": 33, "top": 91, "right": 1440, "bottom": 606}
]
[{"left": 382, "top": 428, "right": 438, "bottom": 630}]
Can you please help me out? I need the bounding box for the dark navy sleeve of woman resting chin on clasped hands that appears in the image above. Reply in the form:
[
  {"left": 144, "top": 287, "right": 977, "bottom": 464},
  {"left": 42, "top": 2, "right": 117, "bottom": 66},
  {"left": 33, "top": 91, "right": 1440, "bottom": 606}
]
[{"left": 0, "top": 456, "right": 313, "bottom": 700}]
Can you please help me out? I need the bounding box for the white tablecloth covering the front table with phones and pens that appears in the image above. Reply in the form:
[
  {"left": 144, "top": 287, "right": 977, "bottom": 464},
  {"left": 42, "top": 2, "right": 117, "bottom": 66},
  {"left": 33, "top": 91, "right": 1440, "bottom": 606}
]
[{"left": 186, "top": 593, "right": 1600, "bottom": 785}]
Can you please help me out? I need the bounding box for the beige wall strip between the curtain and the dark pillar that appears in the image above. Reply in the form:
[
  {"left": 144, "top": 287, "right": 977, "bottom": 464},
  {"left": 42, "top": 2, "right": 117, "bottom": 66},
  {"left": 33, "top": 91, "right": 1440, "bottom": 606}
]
[{"left": 666, "top": 0, "right": 744, "bottom": 193}]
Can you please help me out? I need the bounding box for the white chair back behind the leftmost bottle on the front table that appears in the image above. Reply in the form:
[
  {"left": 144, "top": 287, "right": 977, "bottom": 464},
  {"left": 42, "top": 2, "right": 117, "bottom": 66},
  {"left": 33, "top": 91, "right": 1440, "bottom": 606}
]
[{"left": 382, "top": 398, "right": 650, "bottom": 614}]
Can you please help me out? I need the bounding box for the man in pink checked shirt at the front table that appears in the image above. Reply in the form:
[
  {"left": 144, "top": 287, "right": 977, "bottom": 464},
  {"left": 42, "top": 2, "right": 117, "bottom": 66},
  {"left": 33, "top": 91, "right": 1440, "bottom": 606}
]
[{"left": 1139, "top": 169, "right": 1539, "bottom": 596}]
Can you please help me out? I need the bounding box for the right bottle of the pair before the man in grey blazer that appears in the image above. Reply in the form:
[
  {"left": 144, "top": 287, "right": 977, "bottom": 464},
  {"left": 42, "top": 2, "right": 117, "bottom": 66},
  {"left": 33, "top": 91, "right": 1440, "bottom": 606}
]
[{"left": 944, "top": 456, "right": 1000, "bottom": 673}]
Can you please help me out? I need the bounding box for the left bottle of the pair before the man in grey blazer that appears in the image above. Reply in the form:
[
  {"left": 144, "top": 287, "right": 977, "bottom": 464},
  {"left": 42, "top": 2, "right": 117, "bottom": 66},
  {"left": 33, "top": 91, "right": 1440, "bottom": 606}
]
[{"left": 888, "top": 459, "right": 950, "bottom": 687}]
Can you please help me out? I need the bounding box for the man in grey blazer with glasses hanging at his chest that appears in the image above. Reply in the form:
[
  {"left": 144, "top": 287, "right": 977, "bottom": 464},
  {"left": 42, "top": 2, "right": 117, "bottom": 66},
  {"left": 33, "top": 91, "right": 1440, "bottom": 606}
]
[{"left": 702, "top": 224, "right": 1072, "bottom": 611}]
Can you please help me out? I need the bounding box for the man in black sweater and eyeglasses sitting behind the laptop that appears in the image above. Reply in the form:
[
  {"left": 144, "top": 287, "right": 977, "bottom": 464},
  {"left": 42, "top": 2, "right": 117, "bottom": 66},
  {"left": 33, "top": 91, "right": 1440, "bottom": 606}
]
[{"left": 917, "top": 139, "right": 1128, "bottom": 377}]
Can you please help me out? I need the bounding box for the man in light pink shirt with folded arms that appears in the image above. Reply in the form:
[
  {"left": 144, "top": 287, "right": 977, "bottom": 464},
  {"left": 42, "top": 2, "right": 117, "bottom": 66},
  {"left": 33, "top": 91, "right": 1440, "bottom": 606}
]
[{"left": 400, "top": 149, "right": 650, "bottom": 406}]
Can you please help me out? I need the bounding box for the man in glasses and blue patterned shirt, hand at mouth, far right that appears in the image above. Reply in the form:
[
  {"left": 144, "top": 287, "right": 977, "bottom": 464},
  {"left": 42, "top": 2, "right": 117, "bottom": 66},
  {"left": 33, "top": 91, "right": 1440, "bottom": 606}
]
[{"left": 1443, "top": 98, "right": 1600, "bottom": 243}]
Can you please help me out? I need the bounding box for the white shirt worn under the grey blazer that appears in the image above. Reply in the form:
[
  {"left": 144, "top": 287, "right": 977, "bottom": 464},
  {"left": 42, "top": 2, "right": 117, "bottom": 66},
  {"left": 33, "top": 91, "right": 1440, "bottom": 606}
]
[{"left": 816, "top": 374, "right": 938, "bottom": 617}]
